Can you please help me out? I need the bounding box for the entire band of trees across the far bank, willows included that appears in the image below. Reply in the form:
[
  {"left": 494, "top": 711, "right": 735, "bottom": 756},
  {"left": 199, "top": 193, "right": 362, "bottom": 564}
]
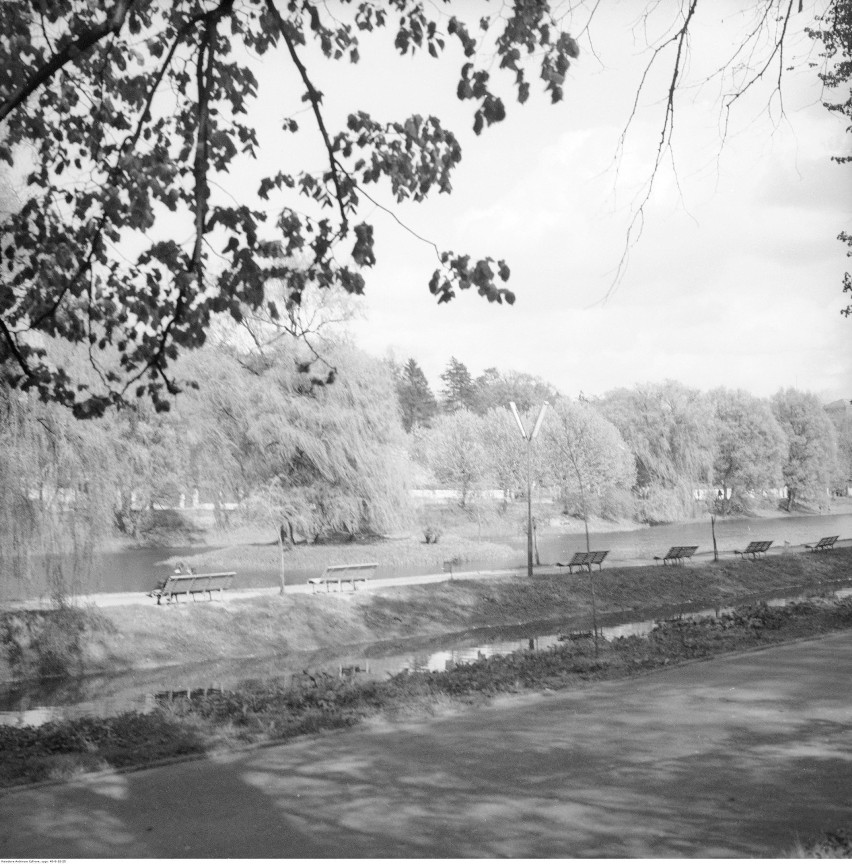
[{"left": 0, "top": 330, "right": 852, "bottom": 585}]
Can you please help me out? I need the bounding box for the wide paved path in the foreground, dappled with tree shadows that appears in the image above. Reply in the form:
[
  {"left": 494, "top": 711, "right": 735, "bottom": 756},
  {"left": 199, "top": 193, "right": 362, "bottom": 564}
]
[{"left": 0, "top": 632, "right": 852, "bottom": 858}]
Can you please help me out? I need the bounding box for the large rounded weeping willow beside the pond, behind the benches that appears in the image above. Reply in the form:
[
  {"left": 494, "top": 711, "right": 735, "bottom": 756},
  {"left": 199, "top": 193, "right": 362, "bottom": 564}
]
[{"left": 179, "top": 338, "right": 409, "bottom": 586}]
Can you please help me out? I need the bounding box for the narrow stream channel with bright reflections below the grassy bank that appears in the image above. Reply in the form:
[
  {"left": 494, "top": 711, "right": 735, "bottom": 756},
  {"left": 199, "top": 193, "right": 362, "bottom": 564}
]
[{"left": 0, "top": 585, "right": 852, "bottom": 726}]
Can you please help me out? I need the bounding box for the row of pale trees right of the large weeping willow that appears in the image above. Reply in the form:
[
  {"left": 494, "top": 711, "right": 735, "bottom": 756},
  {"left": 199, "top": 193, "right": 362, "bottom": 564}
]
[{"left": 391, "top": 357, "right": 852, "bottom": 522}]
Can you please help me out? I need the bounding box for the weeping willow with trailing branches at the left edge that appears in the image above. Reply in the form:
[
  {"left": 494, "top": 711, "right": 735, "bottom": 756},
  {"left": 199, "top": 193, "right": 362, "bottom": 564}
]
[{"left": 0, "top": 387, "right": 112, "bottom": 605}]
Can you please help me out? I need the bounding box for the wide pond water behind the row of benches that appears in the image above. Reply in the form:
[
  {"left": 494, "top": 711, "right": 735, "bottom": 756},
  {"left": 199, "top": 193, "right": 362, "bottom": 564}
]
[{"left": 0, "top": 513, "right": 852, "bottom": 600}]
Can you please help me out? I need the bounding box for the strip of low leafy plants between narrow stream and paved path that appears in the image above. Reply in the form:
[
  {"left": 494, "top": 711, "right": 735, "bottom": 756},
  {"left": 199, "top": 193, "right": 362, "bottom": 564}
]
[{"left": 0, "top": 598, "right": 852, "bottom": 787}]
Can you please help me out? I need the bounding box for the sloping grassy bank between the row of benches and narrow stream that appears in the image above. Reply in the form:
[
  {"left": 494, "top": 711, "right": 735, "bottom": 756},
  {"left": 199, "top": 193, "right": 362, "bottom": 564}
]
[{"left": 0, "top": 548, "right": 852, "bottom": 680}]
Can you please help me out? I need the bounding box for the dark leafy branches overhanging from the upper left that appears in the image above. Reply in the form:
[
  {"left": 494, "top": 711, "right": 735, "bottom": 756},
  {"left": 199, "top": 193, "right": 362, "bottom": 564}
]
[{"left": 0, "top": 0, "right": 578, "bottom": 417}]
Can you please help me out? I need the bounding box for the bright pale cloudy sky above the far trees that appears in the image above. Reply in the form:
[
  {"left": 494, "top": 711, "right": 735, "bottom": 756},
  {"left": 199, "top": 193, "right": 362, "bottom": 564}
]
[{"left": 243, "top": 2, "right": 852, "bottom": 400}]
